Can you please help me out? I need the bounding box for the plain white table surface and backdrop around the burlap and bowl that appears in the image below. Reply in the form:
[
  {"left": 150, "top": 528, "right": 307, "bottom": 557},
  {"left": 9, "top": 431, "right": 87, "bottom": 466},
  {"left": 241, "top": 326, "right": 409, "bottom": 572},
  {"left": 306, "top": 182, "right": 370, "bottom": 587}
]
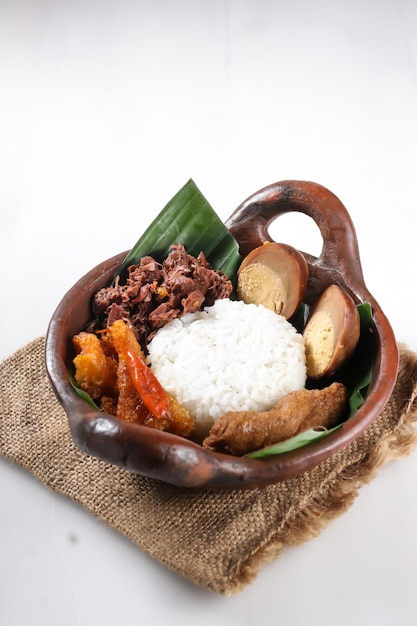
[{"left": 0, "top": 0, "right": 417, "bottom": 626}]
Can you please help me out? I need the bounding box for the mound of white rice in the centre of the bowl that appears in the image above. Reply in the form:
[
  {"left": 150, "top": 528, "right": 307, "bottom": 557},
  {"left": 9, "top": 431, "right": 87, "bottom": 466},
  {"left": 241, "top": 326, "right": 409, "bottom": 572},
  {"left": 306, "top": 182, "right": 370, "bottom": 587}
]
[{"left": 148, "top": 298, "right": 306, "bottom": 436}]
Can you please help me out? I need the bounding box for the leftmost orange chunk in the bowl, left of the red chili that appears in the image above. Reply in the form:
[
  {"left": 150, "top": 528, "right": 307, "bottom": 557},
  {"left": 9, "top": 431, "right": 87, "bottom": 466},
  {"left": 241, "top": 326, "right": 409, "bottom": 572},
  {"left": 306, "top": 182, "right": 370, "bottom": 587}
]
[{"left": 73, "top": 332, "right": 117, "bottom": 400}]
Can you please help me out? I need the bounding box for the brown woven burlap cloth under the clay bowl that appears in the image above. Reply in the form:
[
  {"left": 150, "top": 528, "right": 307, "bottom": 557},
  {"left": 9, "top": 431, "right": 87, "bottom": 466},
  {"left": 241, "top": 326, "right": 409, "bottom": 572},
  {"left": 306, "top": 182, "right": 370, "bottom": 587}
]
[{"left": 0, "top": 338, "right": 417, "bottom": 594}]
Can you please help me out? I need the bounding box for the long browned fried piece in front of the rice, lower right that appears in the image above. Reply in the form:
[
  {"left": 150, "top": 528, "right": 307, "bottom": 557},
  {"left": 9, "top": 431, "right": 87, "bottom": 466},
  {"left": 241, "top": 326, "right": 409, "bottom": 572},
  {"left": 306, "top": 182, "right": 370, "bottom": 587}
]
[{"left": 203, "top": 383, "right": 347, "bottom": 456}]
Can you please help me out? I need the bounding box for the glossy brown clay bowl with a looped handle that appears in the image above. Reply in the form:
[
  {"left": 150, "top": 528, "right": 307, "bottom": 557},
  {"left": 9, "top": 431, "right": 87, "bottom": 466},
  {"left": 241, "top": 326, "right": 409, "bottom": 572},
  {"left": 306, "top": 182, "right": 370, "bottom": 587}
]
[{"left": 45, "top": 181, "right": 398, "bottom": 489}]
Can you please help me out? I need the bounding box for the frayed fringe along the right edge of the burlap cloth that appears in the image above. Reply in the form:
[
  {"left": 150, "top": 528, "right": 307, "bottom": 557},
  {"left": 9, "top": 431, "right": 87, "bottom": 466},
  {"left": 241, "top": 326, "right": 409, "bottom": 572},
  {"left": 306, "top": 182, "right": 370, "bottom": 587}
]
[{"left": 225, "top": 344, "right": 417, "bottom": 595}]
